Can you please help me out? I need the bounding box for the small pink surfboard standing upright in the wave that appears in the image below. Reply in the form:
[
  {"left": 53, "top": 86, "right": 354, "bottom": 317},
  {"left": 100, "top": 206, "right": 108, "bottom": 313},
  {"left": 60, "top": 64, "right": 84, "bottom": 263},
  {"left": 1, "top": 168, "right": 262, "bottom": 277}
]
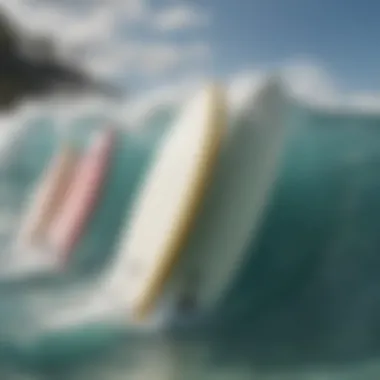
[{"left": 48, "top": 130, "right": 115, "bottom": 263}]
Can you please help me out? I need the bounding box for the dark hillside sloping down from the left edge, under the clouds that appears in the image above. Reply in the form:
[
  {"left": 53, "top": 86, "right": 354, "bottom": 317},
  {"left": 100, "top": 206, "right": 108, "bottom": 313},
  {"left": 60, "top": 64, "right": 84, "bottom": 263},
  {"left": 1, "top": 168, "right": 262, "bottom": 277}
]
[{"left": 0, "top": 9, "right": 122, "bottom": 111}]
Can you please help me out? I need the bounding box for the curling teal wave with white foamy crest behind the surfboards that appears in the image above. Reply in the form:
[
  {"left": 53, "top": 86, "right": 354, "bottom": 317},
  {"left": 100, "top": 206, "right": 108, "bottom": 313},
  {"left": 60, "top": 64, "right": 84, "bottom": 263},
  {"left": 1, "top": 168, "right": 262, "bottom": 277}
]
[{"left": 0, "top": 68, "right": 380, "bottom": 378}]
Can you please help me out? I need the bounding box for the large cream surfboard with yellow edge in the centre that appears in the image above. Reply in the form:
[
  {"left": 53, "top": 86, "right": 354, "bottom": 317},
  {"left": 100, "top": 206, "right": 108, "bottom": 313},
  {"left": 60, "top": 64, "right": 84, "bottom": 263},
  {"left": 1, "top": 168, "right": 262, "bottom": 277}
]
[{"left": 107, "top": 85, "right": 226, "bottom": 321}]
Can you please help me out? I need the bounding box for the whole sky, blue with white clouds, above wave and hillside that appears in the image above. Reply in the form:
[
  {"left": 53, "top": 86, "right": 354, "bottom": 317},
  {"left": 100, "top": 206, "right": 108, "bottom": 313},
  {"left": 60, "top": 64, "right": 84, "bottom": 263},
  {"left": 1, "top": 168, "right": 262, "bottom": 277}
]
[{"left": 0, "top": 0, "right": 380, "bottom": 90}]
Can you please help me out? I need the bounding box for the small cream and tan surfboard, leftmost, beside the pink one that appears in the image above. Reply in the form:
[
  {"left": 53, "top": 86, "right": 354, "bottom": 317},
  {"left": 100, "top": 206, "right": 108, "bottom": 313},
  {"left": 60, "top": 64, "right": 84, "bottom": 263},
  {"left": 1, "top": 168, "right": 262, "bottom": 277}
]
[{"left": 18, "top": 142, "right": 79, "bottom": 246}]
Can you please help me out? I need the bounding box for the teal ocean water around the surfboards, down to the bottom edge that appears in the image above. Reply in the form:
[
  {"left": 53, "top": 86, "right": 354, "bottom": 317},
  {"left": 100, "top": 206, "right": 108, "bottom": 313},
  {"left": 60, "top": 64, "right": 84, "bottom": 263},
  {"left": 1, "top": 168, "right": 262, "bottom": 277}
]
[{"left": 0, "top": 78, "right": 380, "bottom": 380}]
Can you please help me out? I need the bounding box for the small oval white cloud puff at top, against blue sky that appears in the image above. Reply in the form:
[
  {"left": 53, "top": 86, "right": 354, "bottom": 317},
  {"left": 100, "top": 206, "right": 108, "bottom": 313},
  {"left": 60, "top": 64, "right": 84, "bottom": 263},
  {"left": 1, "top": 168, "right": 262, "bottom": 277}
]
[{"left": 154, "top": 4, "right": 209, "bottom": 32}]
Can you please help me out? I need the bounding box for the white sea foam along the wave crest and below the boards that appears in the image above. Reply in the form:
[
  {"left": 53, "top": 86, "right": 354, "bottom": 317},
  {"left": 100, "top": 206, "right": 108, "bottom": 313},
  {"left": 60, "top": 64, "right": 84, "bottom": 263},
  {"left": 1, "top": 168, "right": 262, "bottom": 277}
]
[{"left": 0, "top": 65, "right": 380, "bottom": 336}]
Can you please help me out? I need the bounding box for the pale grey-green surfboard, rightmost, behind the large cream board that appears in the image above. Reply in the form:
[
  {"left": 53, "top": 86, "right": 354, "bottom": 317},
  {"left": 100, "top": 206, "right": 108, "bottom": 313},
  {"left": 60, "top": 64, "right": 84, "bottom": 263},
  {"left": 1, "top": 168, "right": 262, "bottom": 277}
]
[{"left": 171, "top": 78, "right": 286, "bottom": 314}]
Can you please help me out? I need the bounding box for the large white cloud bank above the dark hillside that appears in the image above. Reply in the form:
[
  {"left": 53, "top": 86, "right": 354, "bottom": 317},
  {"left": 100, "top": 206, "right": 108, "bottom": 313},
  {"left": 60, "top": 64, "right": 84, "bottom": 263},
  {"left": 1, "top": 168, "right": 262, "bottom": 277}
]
[{"left": 0, "top": 0, "right": 211, "bottom": 80}]
